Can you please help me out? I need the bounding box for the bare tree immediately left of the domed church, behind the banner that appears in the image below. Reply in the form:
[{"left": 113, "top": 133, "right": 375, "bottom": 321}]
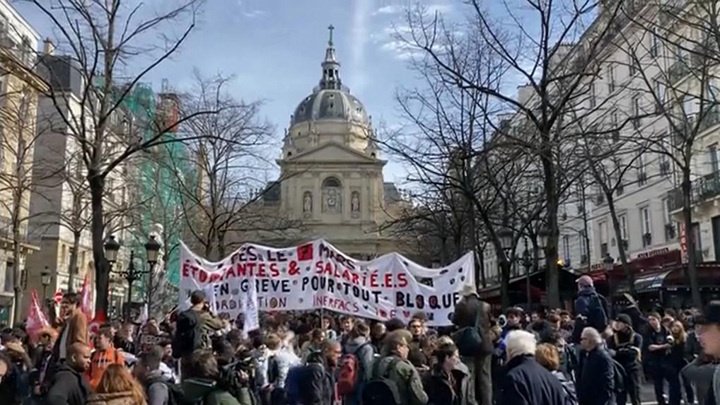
[{"left": 172, "top": 74, "right": 296, "bottom": 259}]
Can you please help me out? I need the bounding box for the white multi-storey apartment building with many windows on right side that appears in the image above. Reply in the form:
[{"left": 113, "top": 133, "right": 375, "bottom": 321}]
[{"left": 560, "top": 2, "right": 720, "bottom": 305}]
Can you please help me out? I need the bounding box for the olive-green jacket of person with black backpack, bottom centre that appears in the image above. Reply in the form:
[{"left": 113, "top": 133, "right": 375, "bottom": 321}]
[{"left": 372, "top": 354, "right": 428, "bottom": 405}]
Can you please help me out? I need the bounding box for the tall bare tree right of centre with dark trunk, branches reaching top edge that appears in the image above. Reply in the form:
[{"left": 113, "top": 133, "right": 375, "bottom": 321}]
[{"left": 401, "top": 0, "right": 622, "bottom": 307}]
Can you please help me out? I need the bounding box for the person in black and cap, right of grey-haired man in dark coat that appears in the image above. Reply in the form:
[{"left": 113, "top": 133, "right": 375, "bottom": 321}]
[{"left": 607, "top": 314, "right": 642, "bottom": 405}]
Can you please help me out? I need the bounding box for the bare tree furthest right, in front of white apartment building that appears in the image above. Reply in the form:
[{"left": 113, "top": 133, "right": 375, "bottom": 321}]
[{"left": 616, "top": 0, "right": 720, "bottom": 307}]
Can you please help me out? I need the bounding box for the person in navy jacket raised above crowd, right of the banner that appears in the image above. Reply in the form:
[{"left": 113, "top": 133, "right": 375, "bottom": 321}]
[{"left": 572, "top": 275, "right": 610, "bottom": 343}]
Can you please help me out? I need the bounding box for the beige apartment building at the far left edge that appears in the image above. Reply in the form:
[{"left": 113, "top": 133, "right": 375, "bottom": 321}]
[{"left": 0, "top": 0, "right": 45, "bottom": 323}]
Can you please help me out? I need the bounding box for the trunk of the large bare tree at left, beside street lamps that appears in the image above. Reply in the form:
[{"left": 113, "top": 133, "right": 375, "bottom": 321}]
[{"left": 88, "top": 174, "right": 110, "bottom": 314}]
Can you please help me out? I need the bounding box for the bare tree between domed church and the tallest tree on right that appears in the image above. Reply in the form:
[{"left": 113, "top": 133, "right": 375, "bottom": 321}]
[{"left": 376, "top": 21, "right": 543, "bottom": 305}]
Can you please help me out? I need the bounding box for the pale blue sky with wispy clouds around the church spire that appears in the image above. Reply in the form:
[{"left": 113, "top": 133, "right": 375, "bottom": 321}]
[{"left": 13, "top": 0, "right": 462, "bottom": 182}]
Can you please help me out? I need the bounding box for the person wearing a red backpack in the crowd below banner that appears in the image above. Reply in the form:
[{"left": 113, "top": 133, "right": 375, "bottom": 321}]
[{"left": 337, "top": 320, "right": 375, "bottom": 405}]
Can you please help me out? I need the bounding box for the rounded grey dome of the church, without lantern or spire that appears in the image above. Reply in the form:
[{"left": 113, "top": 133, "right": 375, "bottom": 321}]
[{"left": 290, "top": 89, "right": 369, "bottom": 125}]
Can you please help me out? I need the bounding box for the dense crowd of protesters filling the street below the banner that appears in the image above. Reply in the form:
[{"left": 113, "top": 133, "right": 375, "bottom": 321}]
[{"left": 0, "top": 277, "right": 720, "bottom": 405}]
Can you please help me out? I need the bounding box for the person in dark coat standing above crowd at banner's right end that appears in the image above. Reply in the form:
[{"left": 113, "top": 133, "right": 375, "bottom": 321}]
[{"left": 452, "top": 284, "right": 493, "bottom": 405}]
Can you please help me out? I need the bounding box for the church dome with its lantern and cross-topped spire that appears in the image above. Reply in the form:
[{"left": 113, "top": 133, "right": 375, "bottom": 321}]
[{"left": 290, "top": 26, "right": 370, "bottom": 126}]
